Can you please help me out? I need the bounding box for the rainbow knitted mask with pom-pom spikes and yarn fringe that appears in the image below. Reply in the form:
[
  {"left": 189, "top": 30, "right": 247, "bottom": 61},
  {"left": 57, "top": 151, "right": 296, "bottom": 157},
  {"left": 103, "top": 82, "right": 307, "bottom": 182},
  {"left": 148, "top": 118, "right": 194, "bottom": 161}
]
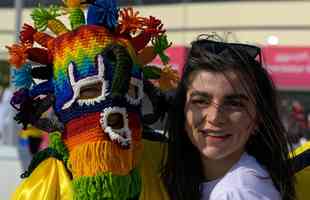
[{"left": 7, "top": 0, "right": 177, "bottom": 200}]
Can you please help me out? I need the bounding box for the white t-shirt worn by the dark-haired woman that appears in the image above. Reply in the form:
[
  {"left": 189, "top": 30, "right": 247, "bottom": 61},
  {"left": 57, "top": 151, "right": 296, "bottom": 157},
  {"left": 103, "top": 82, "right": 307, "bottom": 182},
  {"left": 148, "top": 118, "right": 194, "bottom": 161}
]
[{"left": 201, "top": 153, "right": 281, "bottom": 200}]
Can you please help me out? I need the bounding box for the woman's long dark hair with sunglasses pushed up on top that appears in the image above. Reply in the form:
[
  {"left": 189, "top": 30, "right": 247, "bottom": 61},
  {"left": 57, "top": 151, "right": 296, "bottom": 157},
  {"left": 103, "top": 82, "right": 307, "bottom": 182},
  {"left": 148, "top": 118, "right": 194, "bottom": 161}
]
[{"left": 162, "top": 35, "right": 296, "bottom": 200}]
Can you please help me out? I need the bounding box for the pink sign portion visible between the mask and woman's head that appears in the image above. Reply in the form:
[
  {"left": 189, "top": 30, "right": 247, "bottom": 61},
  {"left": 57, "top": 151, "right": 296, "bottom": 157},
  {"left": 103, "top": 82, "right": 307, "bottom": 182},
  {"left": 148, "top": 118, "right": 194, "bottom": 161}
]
[{"left": 151, "top": 46, "right": 187, "bottom": 74}]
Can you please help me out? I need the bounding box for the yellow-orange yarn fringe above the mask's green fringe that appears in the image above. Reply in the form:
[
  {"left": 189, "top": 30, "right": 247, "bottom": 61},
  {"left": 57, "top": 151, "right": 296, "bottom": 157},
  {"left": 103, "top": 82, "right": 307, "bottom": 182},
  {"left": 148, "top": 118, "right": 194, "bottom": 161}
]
[{"left": 68, "top": 141, "right": 143, "bottom": 178}]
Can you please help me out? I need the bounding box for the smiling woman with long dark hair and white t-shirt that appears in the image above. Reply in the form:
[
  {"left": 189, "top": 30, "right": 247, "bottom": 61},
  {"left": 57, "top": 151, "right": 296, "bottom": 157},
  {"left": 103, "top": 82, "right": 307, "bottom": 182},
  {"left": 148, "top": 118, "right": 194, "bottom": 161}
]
[{"left": 162, "top": 35, "right": 296, "bottom": 200}]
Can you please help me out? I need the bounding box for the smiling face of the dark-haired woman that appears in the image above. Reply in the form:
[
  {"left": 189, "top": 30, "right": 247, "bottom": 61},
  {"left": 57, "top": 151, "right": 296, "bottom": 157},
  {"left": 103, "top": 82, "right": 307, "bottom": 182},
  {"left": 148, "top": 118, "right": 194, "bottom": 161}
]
[{"left": 184, "top": 70, "right": 256, "bottom": 163}]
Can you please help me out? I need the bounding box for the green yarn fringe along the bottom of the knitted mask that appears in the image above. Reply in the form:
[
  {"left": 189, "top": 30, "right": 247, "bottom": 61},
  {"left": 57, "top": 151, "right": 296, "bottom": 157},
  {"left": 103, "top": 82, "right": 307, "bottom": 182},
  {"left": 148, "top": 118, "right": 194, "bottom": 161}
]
[{"left": 72, "top": 169, "right": 141, "bottom": 200}]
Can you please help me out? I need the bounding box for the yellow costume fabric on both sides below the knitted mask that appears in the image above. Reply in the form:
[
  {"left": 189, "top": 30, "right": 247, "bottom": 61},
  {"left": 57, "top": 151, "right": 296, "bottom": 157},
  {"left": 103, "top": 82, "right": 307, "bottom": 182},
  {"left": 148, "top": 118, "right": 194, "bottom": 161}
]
[{"left": 12, "top": 140, "right": 169, "bottom": 200}]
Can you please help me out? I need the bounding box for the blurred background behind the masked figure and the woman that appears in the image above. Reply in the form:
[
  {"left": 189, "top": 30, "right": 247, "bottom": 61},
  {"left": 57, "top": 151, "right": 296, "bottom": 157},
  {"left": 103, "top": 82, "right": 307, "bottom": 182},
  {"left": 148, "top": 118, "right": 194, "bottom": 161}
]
[{"left": 0, "top": 0, "right": 310, "bottom": 199}]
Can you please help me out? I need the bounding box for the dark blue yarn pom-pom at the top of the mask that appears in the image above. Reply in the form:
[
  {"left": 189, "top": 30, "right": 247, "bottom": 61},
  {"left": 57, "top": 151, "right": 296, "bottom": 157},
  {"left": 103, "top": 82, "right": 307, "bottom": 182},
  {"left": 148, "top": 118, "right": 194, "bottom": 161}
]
[{"left": 87, "top": 0, "right": 118, "bottom": 30}]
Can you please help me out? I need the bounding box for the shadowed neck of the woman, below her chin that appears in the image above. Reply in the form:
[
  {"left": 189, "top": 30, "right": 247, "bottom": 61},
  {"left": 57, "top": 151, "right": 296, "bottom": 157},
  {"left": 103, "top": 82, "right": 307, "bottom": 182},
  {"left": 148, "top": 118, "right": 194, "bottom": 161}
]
[{"left": 201, "top": 152, "right": 243, "bottom": 181}]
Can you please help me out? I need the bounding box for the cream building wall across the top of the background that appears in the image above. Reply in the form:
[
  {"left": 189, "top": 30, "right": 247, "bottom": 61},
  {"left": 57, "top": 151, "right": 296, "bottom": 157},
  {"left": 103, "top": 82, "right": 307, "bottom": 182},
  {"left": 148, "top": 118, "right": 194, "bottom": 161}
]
[{"left": 0, "top": 1, "right": 310, "bottom": 59}]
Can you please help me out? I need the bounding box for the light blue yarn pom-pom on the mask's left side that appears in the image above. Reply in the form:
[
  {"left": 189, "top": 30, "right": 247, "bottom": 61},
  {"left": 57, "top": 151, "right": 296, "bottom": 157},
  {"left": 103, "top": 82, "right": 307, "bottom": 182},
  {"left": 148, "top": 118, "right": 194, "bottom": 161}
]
[{"left": 11, "top": 63, "right": 32, "bottom": 89}]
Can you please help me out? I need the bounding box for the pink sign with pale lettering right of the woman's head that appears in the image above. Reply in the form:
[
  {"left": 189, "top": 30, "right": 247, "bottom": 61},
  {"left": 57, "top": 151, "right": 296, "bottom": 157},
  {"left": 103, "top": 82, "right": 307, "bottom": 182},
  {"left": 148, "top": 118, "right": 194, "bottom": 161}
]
[{"left": 262, "top": 46, "right": 310, "bottom": 90}]
